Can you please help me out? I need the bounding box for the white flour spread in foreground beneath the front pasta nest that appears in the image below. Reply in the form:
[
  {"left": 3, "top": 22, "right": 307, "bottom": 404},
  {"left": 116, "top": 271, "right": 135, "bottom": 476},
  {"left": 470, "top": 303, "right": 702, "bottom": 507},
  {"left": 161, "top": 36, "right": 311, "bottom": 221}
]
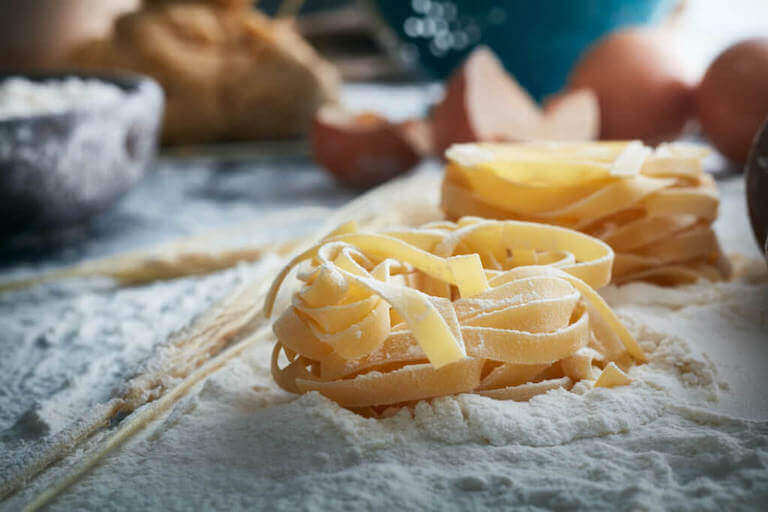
[{"left": 7, "top": 175, "right": 768, "bottom": 510}]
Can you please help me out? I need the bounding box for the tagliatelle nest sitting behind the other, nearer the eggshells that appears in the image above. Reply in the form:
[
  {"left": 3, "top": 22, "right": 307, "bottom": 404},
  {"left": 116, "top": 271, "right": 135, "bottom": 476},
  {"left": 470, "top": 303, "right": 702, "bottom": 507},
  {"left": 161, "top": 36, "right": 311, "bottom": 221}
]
[{"left": 442, "top": 141, "right": 730, "bottom": 285}]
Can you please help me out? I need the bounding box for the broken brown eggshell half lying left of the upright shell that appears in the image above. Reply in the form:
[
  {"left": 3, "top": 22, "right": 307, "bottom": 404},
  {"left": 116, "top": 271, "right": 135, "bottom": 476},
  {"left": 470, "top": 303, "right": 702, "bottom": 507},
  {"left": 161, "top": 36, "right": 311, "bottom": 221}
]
[{"left": 310, "top": 106, "right": 422, "bottom": 188}]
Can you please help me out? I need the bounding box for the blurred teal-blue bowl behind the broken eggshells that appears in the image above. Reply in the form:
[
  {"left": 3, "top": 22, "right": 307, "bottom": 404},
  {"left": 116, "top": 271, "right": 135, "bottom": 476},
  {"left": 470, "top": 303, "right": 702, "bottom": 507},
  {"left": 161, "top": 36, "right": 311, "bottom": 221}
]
[{"left": 373, "top": 0, "right": 678, "bottom": 100}]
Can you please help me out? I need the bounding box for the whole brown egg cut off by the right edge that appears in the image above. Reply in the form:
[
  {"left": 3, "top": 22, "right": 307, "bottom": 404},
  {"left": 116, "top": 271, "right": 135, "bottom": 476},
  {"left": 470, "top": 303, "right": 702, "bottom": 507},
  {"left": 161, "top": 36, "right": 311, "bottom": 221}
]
[{"left": 696, "top": 38, "right": 768, "bottom": 163}]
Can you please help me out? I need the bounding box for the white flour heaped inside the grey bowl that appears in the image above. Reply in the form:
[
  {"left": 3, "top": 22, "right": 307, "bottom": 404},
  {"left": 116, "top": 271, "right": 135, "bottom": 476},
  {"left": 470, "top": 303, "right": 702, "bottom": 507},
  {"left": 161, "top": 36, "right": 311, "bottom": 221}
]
[{"left": 0, "top": 77, "right": 125, "bottom": 120}]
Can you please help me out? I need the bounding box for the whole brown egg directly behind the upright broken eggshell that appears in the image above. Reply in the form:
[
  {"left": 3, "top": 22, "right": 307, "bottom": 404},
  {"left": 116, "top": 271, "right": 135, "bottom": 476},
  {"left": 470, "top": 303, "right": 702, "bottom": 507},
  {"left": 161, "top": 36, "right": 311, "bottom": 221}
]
[{"left": 568, "top": 28, "right": 695, "bottom": 144}]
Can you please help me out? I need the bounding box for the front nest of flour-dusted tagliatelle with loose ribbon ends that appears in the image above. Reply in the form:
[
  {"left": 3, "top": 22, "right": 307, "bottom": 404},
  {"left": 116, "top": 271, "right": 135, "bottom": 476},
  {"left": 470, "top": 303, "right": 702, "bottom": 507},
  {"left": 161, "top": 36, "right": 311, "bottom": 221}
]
[{"left": 265, "top": 217, "right": 645, "bottom": 415}]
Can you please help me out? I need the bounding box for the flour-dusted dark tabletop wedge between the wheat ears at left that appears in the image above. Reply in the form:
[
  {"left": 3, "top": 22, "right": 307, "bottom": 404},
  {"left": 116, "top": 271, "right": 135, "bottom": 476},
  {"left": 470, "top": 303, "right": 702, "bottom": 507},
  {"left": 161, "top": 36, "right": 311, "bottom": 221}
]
[{"left": 0, "top": 267, "right": 260, "bottom": 492}]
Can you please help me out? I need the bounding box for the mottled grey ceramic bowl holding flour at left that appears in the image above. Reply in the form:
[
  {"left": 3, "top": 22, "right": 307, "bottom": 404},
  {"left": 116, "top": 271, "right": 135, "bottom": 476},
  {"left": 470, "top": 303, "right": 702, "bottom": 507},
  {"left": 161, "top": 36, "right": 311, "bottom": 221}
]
[{"left": 0, "top": 71, "right": 163, "bottom": 236}]
